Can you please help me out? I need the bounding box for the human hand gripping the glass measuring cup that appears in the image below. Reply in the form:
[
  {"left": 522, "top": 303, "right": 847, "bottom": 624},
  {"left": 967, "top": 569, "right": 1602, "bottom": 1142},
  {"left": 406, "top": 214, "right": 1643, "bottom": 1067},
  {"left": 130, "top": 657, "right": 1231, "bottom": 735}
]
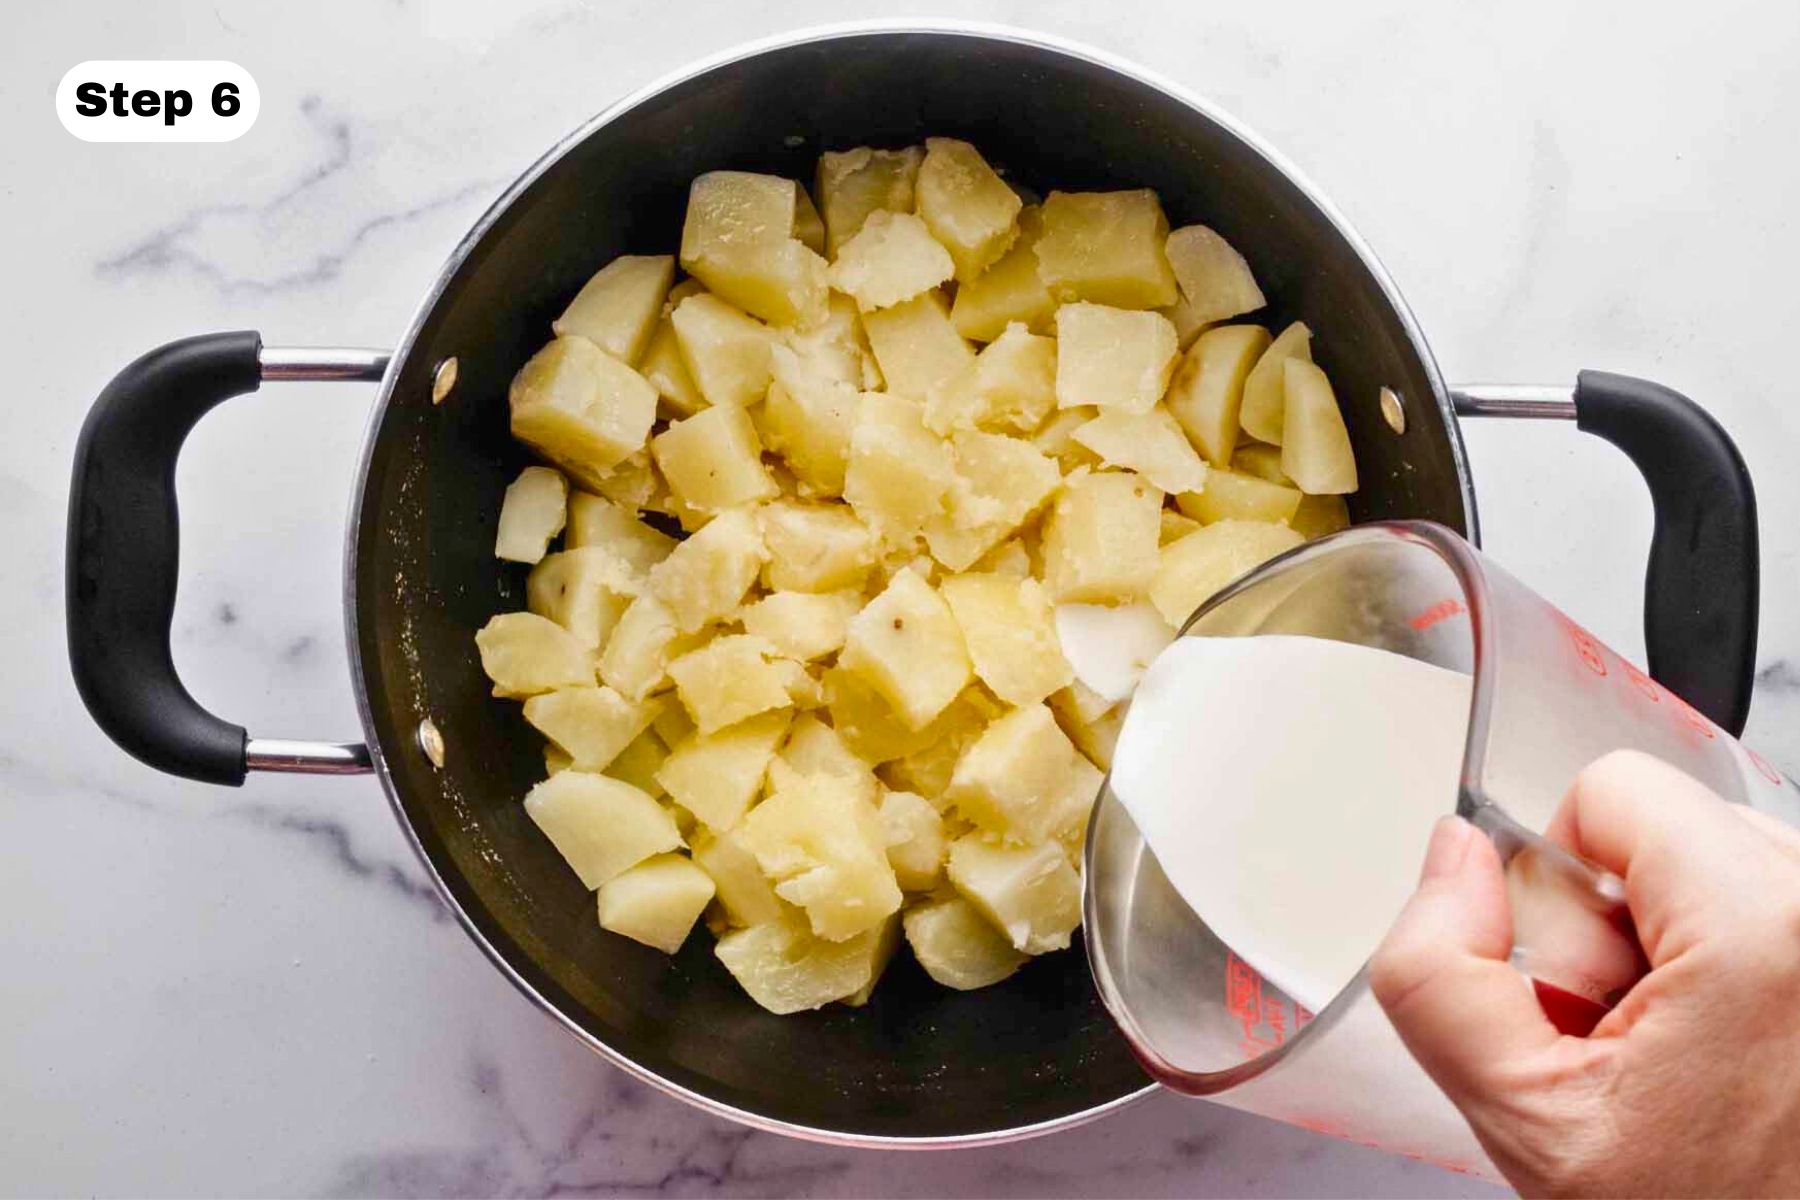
[{"left": 1370, "top": 752, "right": 1800, "bottom": 1196}]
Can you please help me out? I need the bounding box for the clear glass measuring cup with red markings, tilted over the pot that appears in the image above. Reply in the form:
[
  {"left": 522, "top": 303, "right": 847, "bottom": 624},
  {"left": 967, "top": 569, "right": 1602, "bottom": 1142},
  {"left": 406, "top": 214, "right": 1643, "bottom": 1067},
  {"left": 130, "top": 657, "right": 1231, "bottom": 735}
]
[{"left": 1084, "top": 522, "right": 1800, "bottom": 1178}]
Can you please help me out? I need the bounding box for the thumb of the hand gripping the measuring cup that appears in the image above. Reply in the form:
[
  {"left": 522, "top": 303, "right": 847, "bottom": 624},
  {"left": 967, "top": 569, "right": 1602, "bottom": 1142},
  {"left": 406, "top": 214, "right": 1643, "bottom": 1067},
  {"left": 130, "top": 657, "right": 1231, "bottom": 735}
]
[{"left": 1368, "top": 817, "right": 1559, "bottom": 1106}]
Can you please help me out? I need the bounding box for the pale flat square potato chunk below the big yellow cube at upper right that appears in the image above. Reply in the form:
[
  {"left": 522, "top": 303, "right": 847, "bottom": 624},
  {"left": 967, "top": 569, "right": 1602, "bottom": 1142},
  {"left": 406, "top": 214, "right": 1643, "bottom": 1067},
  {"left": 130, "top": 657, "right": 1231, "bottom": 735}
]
[{"left": 1057, "top": 304, "right": 1179, "bottom": 412}]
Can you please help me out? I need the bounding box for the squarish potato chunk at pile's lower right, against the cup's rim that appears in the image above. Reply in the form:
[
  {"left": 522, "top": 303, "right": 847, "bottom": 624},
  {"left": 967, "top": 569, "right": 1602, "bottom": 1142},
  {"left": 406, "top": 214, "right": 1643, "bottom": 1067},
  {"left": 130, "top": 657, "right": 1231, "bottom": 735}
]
[{"left": 949, "top": 833, "right": 1082, "bottom": 954}]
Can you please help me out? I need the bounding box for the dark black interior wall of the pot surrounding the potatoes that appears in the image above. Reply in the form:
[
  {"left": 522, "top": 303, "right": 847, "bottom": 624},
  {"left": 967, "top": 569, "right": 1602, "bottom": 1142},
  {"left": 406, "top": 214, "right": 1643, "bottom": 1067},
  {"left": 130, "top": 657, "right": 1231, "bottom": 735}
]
[{"left": 353, "top": 32, "right": 1467, "bottom": 1139}]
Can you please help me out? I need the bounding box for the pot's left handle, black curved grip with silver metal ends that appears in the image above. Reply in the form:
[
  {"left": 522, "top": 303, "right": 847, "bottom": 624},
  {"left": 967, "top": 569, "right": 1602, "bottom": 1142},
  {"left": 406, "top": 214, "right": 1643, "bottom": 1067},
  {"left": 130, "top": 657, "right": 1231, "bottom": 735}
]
[{"left": 65, "top": 331, "right": 387, "bottom": 786}]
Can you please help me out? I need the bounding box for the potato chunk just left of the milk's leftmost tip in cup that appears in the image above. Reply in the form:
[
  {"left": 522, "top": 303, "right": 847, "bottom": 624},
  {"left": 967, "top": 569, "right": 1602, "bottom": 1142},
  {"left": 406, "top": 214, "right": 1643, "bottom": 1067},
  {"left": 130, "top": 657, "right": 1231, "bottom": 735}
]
[{"left": 945, "top": 703, "right": 1100, "bottom": 842}]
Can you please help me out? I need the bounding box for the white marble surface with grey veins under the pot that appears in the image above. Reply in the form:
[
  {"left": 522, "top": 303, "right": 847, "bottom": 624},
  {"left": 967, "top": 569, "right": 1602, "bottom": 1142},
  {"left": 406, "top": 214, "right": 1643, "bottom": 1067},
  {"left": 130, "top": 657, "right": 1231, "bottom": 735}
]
[{"left": 0, "top": 0, "right": 1800, "bottom": 1196}]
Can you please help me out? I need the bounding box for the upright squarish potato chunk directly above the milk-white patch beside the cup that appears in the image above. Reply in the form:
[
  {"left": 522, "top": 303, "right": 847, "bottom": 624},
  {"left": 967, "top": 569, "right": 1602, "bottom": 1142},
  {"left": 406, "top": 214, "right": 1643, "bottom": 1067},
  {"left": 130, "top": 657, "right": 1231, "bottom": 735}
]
[{"left": 1044, "top": 471, "right": 1179, "bottom": 604}]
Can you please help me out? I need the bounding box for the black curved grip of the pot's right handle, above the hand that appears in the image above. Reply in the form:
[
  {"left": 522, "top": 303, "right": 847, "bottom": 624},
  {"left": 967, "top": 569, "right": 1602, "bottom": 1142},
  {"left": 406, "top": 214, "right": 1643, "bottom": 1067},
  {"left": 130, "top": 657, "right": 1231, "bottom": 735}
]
[{"left": 1575, "top": 371, "right": 1759, "bottom": 736}]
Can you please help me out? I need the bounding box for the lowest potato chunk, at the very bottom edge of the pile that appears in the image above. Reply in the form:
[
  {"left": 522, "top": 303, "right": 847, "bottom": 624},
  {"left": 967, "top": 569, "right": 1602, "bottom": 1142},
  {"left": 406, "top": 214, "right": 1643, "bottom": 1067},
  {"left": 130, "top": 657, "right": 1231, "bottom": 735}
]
[{"left": 713, "top": 912, "right": 884, "bottom": 1016}]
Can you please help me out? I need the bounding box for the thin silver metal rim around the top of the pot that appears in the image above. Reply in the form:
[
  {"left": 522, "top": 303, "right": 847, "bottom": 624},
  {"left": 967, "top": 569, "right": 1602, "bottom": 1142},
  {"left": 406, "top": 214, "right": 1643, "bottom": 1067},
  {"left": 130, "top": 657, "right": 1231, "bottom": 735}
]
[{"left": 344, "top": 18, "right": 1478, "bottom": 1150}]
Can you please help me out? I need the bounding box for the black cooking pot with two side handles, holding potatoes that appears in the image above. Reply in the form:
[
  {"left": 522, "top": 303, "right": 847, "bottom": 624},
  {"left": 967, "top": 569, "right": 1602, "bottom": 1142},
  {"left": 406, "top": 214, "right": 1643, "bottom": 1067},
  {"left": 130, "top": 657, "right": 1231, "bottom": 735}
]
[{"left": 67, "top": 23, "right": 1757, "bottom": 1146}]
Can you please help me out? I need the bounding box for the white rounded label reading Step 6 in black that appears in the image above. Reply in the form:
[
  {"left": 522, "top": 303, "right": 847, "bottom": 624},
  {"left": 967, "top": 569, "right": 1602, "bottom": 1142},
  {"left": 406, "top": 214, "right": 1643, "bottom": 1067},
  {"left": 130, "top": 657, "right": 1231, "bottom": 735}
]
[{"left": 56, "top": 59, "right": 263, "bottom": 142}]
